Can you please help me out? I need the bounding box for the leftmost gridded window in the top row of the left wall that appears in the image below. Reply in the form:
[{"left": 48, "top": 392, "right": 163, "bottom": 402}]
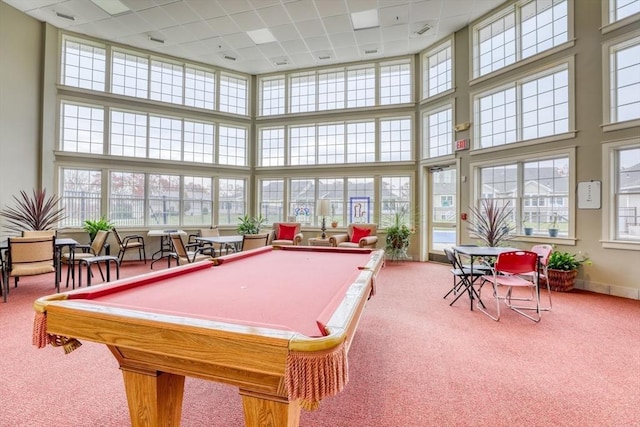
[{"left": 61, "top": 37, "right": 106, "bottom": 91}]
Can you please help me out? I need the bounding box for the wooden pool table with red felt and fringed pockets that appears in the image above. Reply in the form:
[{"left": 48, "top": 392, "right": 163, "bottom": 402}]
[{"left": 33, "top": 246, "right": 384, "bottom": 427}]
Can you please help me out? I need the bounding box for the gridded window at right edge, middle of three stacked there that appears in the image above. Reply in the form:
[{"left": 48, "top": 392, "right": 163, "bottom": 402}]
[{"left": 605, "top": 36, "right": 640, "bottom": 123}]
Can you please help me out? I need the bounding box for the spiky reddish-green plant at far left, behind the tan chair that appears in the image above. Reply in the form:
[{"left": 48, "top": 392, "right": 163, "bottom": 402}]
[{"left": 0, "top": 189, "right": 66, "bottom": 233}]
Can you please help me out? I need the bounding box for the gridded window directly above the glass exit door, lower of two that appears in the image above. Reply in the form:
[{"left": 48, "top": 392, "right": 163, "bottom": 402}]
[{"left": 422, "top": 104, "right": 453, "bottom": 158}]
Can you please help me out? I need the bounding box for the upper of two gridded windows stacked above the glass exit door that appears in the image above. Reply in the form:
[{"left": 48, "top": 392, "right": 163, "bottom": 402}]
[{"left": 422, "top": 40, "right": 453, "bottom": 99}]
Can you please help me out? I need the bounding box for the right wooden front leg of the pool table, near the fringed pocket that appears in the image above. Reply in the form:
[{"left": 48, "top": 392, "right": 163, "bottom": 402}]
[{"left": 240, "top": 390, "right": 300, "bottom": 427}]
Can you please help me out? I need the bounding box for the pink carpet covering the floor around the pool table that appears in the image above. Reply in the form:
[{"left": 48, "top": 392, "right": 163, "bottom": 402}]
[{"left": 0, "top": 262, "right": 640, "bottom": 427}]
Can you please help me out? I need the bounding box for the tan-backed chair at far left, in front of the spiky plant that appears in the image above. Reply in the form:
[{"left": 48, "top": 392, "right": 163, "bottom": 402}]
[{"left": 3, "top": 236, "right": 55, "bottom": 302}]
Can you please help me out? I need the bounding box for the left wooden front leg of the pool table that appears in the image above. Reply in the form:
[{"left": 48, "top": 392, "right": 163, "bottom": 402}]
[{"left": 121, "top": 367, "right": 184, "bottom": 427}]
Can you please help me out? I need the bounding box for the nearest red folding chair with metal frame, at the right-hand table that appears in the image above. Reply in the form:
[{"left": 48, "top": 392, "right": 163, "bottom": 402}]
[{"left": 478, "top": 251, "right": 541, "bottom": 322}]
